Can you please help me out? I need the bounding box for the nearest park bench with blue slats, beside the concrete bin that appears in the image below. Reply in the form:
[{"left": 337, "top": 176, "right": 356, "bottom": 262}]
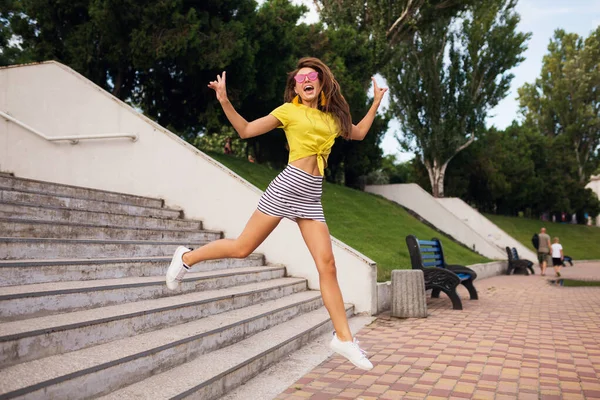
[{"left": 406, "top": 235, "right": 478, "bottom": 310}]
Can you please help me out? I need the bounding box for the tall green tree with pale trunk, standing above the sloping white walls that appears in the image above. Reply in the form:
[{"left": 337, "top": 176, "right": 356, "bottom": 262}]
[{"left": 384, "top": 0, "right": 530, "bottom": 197}]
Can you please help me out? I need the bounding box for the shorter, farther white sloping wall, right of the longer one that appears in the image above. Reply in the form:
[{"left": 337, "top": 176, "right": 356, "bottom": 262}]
[{"left": 437, "top": 197, "right": 537, "bottom": 262}]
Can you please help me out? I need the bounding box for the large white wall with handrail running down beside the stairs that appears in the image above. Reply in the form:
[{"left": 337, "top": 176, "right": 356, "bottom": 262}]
[{"left": 0, "top": 62, "right": 377, "bottom": 314}]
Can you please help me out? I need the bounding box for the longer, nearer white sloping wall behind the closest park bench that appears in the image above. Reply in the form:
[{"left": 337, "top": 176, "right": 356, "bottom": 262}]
[{"left": 365, "top": 183, "right": 506, "bottom": 260}]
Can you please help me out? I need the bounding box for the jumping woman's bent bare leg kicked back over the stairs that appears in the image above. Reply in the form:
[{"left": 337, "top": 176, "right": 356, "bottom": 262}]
[{"left": 183, "top": 210, "right": 281, "bottom": 267}]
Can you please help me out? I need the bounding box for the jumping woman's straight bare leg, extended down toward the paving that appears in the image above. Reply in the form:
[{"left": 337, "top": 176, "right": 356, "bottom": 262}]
[{"left": 297, "top": 219, "right": 352, "bottom": 342}]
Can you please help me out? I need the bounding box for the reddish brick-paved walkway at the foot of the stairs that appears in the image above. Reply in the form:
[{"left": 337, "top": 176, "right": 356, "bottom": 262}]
[{"left": 277, "top": 263, "right": 600, "bottom": 400}]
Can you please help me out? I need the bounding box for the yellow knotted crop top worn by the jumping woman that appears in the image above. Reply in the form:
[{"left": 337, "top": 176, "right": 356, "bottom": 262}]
[{"left": 271, "top": 103, "right": 340, "bottom": 175}]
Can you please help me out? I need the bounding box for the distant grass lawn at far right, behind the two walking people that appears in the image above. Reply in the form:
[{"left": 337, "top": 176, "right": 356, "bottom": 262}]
[{"left": 485, "top": 214, "right": 600, "bottom": 261}]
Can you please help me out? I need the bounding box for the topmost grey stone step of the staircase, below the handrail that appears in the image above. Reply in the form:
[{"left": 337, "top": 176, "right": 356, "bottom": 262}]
[{"left": 0, "top": 175, "right": 164, "bottom": 208}]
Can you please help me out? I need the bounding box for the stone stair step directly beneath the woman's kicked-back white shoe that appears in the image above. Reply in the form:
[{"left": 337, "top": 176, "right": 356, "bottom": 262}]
[{"left": 0, "top": 266, "right": 292, "bottom": 321}]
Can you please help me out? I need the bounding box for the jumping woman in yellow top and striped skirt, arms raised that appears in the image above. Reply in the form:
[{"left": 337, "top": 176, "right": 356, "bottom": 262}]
[{"left": 166, "top": 58, "right": 387, "bottom": 370}]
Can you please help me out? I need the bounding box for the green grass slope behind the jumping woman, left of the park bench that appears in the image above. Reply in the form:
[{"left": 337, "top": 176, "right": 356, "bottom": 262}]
[{"left": 208, "top": 153, "right": 489, "bottom": 282}]
